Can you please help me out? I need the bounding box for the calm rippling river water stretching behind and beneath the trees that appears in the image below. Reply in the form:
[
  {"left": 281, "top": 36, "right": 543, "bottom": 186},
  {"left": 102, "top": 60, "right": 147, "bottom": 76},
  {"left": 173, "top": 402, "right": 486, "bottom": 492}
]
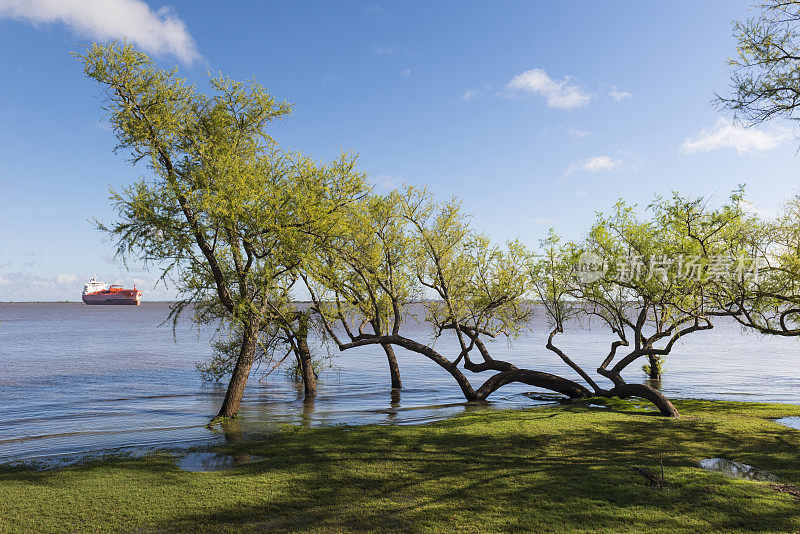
[{"left": 0, "top": 303, "right": 800, "bottom": 462}]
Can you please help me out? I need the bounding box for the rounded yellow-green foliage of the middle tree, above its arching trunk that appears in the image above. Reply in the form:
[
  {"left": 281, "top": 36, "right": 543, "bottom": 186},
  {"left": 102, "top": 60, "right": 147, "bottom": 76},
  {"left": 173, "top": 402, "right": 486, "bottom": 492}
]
[{"left": 310, "top": 187, "right": 531, "bottom": 348}]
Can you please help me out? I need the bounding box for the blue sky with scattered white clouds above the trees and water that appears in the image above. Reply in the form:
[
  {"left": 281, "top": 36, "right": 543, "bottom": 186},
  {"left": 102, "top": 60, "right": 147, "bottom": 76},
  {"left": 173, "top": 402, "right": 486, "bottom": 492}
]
[{"left": 0, "top": 0, "right": 798, "bottom": 301}]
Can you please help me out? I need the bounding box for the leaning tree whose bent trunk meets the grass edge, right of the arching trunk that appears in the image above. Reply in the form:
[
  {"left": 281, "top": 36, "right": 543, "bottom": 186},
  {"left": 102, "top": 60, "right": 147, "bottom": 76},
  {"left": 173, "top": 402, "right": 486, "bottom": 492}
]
[{"left": 533, "top": 195, "right": 749, "bottom": 416}]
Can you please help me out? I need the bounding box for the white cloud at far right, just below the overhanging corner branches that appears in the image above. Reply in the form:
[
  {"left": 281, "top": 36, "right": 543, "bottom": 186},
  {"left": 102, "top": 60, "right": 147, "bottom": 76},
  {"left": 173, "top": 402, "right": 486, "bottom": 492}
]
[{"left": 681, "top": 117, "right": 792, "bottom": 156}]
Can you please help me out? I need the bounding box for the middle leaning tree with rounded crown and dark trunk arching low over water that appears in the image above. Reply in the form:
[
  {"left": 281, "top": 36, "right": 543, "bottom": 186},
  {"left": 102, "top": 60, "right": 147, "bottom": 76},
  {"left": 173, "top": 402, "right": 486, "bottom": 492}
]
[{"left": 305, "top": 187, "right": 592, "bottom": 401}]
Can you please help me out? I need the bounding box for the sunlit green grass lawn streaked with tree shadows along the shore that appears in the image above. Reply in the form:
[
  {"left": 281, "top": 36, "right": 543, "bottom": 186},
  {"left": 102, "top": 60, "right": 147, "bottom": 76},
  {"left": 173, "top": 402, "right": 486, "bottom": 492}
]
[{"left": 0, "top": 399, "right": 800, "bottom": 532}]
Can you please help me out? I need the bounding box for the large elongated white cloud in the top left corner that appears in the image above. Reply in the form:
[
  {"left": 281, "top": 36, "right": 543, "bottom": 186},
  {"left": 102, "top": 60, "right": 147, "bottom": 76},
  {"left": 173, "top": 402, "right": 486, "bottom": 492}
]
[{"left": 0, "top": 0, "right": 200, "bottom": 63}]
